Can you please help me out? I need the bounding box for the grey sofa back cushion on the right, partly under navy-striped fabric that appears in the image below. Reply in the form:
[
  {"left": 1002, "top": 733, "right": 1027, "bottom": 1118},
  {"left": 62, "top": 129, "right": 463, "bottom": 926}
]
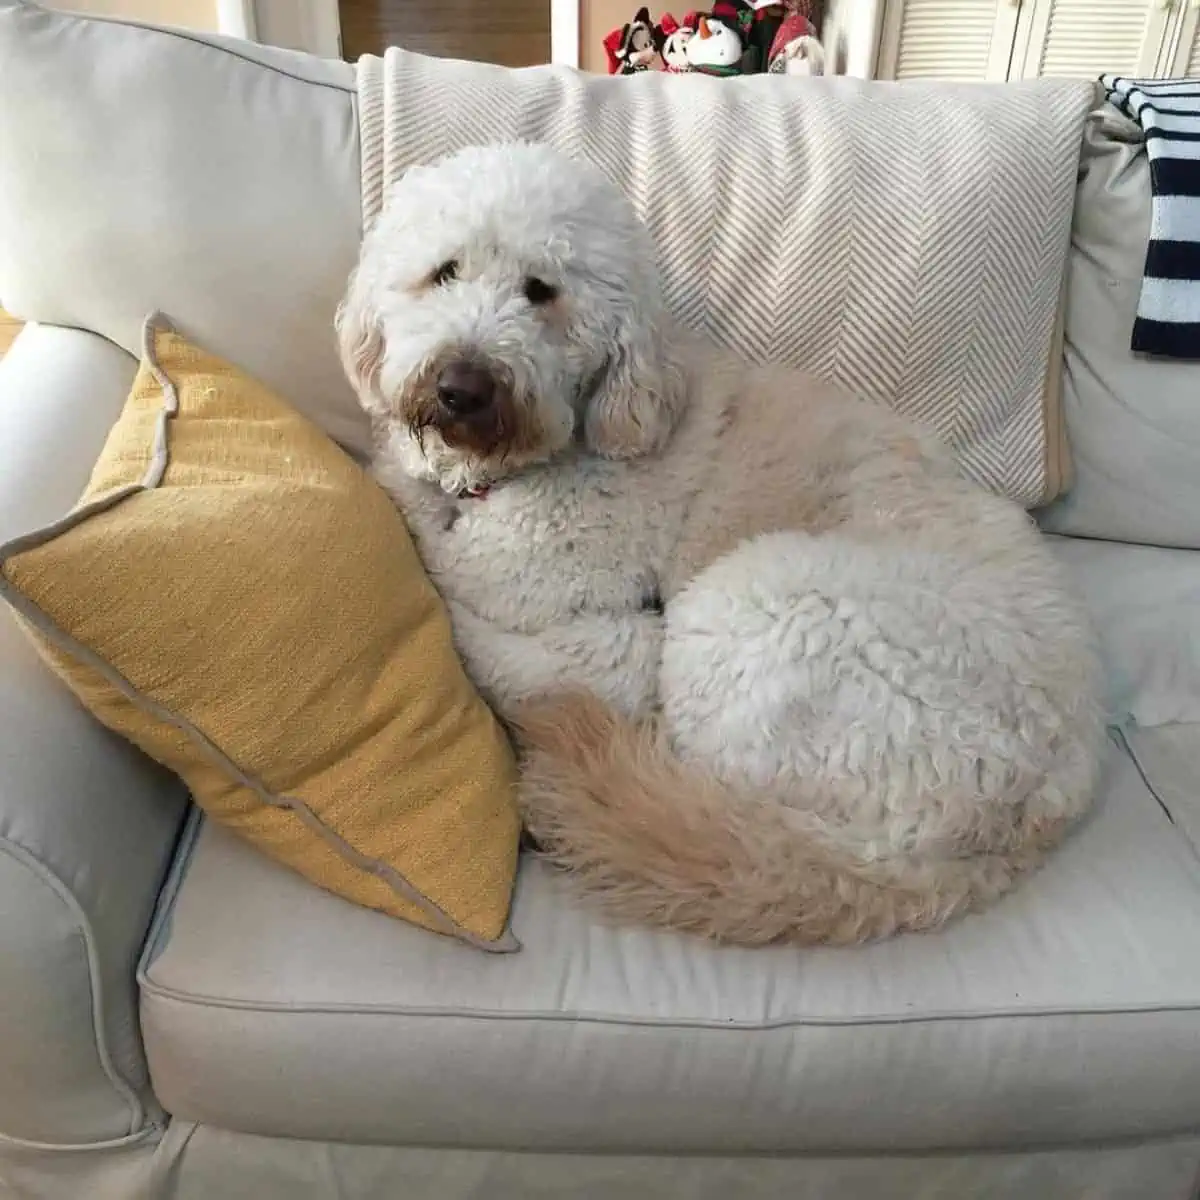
[{"left": 1039, "top": 106, "right": 1200, "bottom": 548}]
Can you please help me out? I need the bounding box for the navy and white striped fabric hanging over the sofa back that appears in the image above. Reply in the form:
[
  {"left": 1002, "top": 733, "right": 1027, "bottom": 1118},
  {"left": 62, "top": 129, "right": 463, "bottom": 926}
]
[{"left": 1100, "top": 74, "right": 1200, "bottom": 359}]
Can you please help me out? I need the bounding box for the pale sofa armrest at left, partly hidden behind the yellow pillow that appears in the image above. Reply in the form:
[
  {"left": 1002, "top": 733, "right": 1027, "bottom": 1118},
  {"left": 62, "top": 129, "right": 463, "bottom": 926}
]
[{"left": 0, "top": 326, "right": 187, "bottom": 1151}]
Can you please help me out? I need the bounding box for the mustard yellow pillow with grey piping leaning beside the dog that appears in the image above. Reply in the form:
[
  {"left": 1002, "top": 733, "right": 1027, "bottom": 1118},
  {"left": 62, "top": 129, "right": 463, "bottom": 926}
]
[{"left": 0, "top": 317, "right": 520, "bottom": 950}]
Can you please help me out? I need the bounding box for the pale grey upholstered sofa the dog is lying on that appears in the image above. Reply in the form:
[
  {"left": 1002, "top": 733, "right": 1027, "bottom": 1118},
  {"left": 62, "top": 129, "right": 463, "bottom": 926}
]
[{"left": 0, "top": 0, "right": 1200, "bottom": 1200}]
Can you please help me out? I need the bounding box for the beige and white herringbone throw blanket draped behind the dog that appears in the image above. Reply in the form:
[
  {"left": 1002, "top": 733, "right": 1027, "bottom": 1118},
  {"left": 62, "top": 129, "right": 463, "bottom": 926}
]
[{"left": 359, "top": 49, "right": 1096, "bottom": 506}]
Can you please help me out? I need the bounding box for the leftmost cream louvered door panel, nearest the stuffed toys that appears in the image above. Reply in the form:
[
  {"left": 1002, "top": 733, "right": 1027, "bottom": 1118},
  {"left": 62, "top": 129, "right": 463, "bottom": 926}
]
[{"left": 876, "top": 0, "right": 1016, "bottom": 79}]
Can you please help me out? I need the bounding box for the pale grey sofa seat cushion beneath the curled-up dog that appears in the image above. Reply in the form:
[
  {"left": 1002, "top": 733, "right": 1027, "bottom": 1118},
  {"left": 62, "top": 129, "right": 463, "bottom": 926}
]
[{"left": 140, "top": 730, "right": 1200, "bottom": 1153}]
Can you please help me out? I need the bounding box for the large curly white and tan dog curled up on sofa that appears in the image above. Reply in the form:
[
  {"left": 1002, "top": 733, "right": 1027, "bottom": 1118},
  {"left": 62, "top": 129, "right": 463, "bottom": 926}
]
[{"left": 337, "top": 144, "right": 1102, "bottom": 943}]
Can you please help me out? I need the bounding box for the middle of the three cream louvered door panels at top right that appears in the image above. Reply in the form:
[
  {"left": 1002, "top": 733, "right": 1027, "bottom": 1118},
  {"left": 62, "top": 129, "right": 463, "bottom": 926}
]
[{"left": 1013, "top": 0, "right": 1174, "bottom": 79}]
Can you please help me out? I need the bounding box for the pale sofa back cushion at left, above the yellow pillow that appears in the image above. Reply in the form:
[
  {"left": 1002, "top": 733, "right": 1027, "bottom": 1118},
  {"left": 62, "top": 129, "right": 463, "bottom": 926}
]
[{"left": 0, "top": 0, "right": 368, "bottom": 451}]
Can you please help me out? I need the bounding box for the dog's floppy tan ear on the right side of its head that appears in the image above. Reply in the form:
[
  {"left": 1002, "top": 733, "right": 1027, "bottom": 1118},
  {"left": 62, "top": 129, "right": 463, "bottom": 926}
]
[{"left": 583, "top": 310, "right": 686, "bottom": 458}]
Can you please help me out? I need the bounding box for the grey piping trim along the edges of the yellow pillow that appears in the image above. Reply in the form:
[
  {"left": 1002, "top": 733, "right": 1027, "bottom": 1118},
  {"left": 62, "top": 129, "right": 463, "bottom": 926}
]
[{"left": 0, "top": 312, "right": 521, "bottom": 954}]
